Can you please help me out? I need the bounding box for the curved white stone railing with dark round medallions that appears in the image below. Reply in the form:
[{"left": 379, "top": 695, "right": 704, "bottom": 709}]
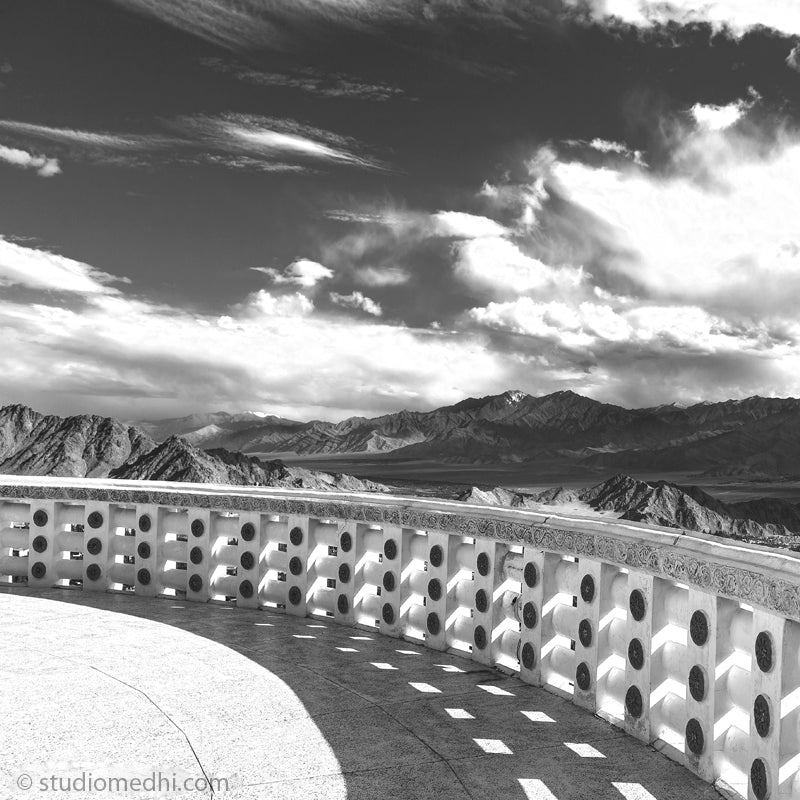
[{"left": 0, "top": 476, "right": 800, "bottom": 800}]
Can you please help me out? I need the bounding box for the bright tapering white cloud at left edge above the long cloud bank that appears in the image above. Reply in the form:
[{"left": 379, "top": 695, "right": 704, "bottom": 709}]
[{"left": 0, "top": 236, "right": 129, "bottom": 295}]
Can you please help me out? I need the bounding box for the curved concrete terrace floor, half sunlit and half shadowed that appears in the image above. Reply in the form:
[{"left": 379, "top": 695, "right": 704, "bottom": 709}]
[{"left": 0, "top": 587, "right": 719, "bottom": 800}]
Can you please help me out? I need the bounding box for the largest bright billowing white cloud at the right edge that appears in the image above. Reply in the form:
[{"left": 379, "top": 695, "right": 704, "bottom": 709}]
[{"left": 544, "top": 129, "right": 800, "bottom": 311}]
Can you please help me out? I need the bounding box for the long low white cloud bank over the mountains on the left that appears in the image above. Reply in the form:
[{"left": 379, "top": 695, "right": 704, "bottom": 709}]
[{"left": 0, "top": 238, "right": 506, "bottom": 418}]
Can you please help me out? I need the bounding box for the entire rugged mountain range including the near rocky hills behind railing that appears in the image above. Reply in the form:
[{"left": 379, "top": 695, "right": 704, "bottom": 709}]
[{"left": 0, "top": 392, "right": 800, "bottom": 547}]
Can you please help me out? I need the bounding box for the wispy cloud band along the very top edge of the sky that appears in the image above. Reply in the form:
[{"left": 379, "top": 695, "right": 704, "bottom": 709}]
[{"left": 112, "top": 0, "right": 800, "bottom": 50}]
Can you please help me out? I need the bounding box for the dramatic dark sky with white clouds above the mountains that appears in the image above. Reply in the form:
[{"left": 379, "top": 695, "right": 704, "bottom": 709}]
[{"left": 0, "top": 0, "right": 800, "bottom": 420}]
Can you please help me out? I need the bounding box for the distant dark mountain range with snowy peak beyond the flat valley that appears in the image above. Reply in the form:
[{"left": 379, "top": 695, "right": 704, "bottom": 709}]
[{"left": 135, "top": 391, "right": 800, "bottom": 476}]
